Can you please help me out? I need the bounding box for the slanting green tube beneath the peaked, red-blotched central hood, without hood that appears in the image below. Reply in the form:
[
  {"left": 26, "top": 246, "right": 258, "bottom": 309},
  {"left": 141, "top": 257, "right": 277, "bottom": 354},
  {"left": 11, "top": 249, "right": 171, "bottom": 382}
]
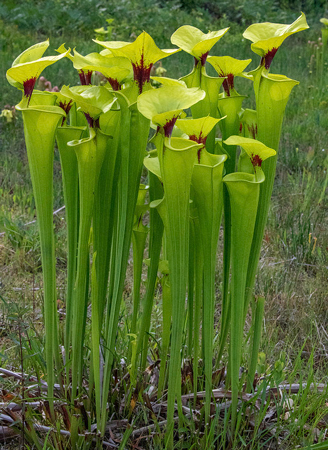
[{"left": 101, "top": 91, "right": 150, "bottom": 434}]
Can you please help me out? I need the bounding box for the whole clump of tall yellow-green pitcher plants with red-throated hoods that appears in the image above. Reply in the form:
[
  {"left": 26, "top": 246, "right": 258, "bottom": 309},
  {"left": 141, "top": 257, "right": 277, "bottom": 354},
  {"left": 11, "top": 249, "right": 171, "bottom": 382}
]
[{"left": 7, "top": 14, "right": 308, "bottom": 449}]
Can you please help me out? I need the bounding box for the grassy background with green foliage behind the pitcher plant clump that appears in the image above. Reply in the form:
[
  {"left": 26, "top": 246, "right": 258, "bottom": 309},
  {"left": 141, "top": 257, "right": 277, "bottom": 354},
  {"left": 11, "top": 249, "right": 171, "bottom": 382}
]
[{"left": 0, "top": 0, "right": 328, "bottom": 448}]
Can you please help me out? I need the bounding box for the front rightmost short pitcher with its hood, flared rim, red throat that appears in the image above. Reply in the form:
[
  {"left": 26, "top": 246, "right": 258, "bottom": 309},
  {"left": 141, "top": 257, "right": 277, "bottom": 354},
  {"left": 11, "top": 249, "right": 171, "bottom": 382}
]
[{"left": 223, "top": 136, "right": 276, "bottom": 430}]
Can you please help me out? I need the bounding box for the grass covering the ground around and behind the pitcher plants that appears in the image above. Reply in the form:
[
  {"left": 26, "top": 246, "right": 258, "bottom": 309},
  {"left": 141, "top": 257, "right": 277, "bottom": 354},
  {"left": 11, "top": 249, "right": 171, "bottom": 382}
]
[{"left": 0, "top": 4, "right": 328, "bottom": 450}]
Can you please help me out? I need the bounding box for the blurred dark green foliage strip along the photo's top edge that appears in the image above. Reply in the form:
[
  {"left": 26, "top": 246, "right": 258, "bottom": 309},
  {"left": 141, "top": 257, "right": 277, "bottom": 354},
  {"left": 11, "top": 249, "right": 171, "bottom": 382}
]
[{"left": 0, "top": 0, "right": 328, "bottom": 39}]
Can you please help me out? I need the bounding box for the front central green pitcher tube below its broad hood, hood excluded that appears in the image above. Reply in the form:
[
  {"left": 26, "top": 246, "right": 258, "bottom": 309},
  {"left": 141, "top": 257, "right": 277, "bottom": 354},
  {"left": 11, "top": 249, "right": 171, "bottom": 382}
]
[{"left": 151, "top": 136, "right": 201, "bottom": 448}]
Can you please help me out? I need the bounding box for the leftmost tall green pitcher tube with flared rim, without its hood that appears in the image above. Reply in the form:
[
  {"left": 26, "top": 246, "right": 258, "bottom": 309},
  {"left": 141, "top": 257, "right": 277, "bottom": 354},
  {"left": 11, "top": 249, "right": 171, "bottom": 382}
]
[{"left": 16, "top": 104, "right": 65, "bottom": 415}]
